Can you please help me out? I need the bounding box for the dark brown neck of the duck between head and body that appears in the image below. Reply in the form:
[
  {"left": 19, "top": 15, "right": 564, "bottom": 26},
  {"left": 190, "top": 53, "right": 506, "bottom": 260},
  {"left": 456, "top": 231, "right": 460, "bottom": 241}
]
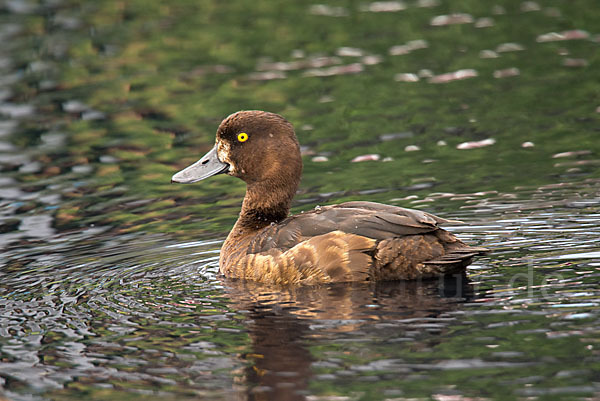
[{"left": 232, "top": 181, "right": 298, "bottom": 234}]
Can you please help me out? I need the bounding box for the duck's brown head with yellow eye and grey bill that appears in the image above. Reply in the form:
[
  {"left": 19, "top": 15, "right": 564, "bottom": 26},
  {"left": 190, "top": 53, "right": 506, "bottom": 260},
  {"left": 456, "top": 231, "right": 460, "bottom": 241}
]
[{"left": 171, "top": 110, "right": 302, "bottom": 191}]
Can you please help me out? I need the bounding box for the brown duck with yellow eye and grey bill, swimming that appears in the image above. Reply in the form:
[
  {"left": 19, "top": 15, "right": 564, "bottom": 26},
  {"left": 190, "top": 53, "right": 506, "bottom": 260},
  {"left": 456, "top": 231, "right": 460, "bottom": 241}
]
[{"left": 171, "top": 110, "right": 488, "bottom": 286}]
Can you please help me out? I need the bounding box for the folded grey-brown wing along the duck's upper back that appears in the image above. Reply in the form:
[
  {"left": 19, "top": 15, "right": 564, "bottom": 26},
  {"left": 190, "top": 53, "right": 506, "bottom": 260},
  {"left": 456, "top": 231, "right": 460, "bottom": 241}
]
[{"left": 249, "top": 202, "right": 451, "bottom": 253}]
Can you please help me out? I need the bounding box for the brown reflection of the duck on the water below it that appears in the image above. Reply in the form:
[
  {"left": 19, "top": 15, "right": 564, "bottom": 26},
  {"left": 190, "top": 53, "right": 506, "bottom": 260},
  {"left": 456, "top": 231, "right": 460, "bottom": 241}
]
[{"left": 224, "top": 275, "right": 473, "bottom": 400}]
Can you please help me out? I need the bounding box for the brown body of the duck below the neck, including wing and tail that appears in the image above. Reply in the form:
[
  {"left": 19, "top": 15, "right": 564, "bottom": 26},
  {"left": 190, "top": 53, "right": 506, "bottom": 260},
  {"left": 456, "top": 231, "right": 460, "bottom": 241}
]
[{"left": 220, "top": 202, "right": 486, "bottom": 284}]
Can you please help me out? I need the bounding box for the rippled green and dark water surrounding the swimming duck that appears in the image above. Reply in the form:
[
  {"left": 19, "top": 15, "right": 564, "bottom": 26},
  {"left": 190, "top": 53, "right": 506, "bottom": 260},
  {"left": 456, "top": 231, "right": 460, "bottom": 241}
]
[{"left": 0, "top": 0, "right": 600, "bottom": 401}]
